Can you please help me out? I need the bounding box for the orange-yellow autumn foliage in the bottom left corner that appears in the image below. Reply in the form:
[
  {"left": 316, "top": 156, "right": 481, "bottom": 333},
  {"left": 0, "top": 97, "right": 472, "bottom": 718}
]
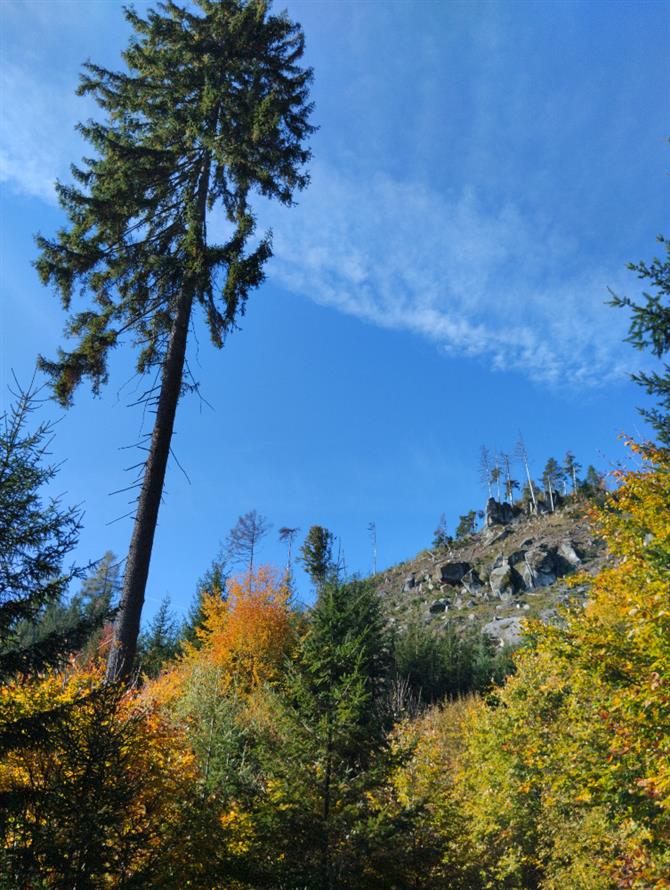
[{"left": 0, "top": 667, "right": 218, "bottom": 890}]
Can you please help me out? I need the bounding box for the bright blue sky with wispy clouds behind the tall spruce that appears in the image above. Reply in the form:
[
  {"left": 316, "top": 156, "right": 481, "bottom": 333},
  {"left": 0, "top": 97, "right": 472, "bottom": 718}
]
[{"left": 0, "top": 0, "right": 670, "bottom": 614}]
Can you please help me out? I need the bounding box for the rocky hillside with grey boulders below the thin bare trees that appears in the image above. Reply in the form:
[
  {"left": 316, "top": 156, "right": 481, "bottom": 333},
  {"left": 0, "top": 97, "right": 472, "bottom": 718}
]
[{"left": 376, "top": 498, "right": 608, "bottom": 644}]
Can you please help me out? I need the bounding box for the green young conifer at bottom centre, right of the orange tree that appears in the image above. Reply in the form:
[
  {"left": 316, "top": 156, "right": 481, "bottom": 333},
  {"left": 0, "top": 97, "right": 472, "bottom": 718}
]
[{"left": 256, "top": 579, "right": 389, "bottom": 890}]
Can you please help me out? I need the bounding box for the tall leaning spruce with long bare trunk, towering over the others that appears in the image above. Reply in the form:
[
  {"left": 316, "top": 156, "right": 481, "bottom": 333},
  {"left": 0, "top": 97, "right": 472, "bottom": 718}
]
[{"left": 36, "top": 0, "right": 313, "bottom": 680}]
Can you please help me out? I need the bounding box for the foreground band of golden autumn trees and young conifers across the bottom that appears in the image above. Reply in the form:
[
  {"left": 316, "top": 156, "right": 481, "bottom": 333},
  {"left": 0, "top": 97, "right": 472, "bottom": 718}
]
[{"left": 0, "top": 443, "right": 670, "bottom": 890}]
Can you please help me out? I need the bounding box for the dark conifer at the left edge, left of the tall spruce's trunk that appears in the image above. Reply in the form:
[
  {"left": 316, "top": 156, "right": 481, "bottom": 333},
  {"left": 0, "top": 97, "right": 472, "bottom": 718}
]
[{"left": 0, "top": 378, "right": 104, "bottom": 680}]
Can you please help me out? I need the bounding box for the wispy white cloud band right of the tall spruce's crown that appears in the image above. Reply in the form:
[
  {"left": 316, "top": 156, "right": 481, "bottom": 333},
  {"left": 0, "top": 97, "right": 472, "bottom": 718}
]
[{"left": 262, "top": 165, "right": 630, "bottom": 386}]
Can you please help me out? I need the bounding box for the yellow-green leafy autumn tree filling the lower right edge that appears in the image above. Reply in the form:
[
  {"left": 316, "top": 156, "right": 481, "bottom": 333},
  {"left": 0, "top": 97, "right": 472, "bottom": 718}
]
[{"left": 459, "top": 443, "right": 670, "bottom": 890}]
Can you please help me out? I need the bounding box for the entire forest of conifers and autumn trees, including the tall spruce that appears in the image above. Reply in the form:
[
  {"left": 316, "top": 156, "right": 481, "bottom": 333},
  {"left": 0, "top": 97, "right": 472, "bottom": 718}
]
[{"left": 0, "top": 0, "right": 670, "bottom": 890}]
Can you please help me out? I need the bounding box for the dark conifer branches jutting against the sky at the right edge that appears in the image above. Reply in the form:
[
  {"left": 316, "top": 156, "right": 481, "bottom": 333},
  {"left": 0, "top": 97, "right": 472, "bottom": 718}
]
[{"left": 611, "top": 235, "right": 670, "bottom": 448}]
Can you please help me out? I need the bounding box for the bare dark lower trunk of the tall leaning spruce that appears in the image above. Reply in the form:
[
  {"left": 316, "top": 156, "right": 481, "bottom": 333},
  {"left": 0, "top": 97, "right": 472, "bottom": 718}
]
[{"left": 107, "top": 291, "right": 193, "bottom": 682}]
